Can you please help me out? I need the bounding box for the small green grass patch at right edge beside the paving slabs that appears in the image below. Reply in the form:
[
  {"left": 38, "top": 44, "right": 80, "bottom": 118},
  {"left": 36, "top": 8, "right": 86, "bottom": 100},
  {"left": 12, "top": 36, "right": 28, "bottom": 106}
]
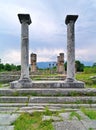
[{"left": 81, "top": 108, "right": 96, "bottom": 120}]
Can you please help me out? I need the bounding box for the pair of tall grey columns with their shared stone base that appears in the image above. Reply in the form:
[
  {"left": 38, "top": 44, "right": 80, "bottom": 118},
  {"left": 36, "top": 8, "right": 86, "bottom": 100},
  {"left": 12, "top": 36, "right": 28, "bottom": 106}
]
[{"left": 11, "top": 14, "right": 84, "bottom": 88}]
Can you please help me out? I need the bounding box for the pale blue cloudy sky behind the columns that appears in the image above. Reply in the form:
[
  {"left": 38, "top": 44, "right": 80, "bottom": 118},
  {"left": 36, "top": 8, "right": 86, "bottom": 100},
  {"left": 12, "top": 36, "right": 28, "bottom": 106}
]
[{"left": 0, "top": 0, "right": 96, "bottom": 64}]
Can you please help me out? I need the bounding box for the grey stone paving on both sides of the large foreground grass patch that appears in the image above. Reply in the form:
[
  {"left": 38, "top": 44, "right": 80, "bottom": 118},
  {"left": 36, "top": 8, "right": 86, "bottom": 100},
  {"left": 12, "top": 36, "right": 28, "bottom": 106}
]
[{"left": 0, "top": 111, "right": 96, "bottom": 130}]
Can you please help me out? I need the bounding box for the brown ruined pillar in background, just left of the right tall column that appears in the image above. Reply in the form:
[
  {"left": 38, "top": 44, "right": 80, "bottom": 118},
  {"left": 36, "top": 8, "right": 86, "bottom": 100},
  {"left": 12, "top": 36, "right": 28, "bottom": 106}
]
[{"left": 57, "top": 53, "right": 65, "bottom": 74}]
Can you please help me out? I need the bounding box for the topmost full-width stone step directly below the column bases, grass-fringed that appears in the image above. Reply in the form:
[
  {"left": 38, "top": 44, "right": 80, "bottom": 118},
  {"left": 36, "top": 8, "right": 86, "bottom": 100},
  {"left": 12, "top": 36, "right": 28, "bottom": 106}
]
[{"left": 0, "top": 88, "right": 96, "bottom": 96}]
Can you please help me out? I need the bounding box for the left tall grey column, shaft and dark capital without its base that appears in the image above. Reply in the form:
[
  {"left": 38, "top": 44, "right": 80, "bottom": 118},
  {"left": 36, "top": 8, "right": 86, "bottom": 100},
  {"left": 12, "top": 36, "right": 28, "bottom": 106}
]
[{"left": 18, "top": 14, "right": 31, "bottom": 81}]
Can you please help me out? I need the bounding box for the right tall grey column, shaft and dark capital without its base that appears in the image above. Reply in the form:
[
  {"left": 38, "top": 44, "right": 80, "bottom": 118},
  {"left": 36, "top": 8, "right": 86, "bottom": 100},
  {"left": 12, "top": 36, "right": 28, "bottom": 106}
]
[{"left": 65, "top": 15, "right": 78, "bottom": 82}]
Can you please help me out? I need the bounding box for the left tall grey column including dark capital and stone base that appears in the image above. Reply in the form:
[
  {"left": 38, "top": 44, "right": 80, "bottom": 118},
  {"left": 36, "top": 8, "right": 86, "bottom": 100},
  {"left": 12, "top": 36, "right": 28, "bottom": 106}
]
[{"left": 11, "top": 14, "right": 32, "bottom": 88}]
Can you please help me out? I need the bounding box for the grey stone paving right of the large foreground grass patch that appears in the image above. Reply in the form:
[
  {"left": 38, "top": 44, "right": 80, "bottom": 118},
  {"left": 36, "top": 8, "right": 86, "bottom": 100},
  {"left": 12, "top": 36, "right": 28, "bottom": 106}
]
[{"left": 53, "top": 112, "right": 96, "bottom": 130}]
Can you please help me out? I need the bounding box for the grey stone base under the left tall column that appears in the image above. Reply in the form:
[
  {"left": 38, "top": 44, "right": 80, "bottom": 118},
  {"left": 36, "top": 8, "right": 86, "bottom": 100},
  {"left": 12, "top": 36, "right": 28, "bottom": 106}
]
[{"left": 10, "top": 78, "right": 32, "bottom": 89}]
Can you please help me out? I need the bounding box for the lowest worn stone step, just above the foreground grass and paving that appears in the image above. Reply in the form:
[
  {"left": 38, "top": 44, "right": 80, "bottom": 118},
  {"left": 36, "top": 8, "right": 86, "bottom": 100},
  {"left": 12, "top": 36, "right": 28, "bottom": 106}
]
[{"left": 0, "top": 103, "right": 96, "bottom": 113}]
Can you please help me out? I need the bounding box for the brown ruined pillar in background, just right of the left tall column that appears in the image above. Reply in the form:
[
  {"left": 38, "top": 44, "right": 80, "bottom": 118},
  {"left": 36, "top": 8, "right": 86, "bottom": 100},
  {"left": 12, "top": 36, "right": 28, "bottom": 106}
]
[{"left": 30, "top": 53, "right": 37, "bottom": 72}]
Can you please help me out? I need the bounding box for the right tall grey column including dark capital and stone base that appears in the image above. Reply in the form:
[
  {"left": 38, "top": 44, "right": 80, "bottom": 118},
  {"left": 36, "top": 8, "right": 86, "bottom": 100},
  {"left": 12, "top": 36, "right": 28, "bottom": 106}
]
[{"left": 64, "top": 15, "right": 84, "bottom": 88}]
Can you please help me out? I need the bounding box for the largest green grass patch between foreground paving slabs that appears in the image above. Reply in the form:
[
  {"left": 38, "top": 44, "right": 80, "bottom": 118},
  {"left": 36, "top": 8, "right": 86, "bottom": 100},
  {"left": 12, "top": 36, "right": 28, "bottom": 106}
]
[{"left": 14, "top": 112, "right": 54, "bottom": 130}]
